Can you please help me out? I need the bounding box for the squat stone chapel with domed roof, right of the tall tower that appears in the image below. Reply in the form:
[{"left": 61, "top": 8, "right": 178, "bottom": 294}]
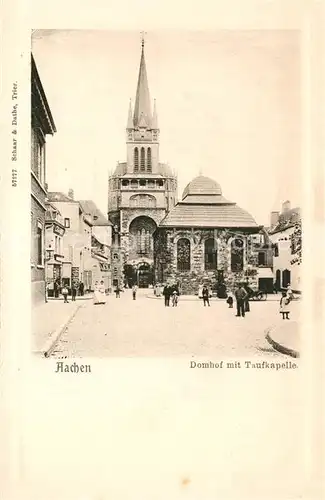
[{"left": 154, "top": 175, "right": 273, "bottom": 294}]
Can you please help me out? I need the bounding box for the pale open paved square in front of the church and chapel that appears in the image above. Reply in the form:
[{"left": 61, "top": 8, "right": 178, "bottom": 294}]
[{"left": 52, "top": 290, "right": 297, "bottom": 360}]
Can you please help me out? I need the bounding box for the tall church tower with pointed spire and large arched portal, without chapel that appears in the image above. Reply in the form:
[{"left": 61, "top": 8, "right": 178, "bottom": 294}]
[{"left": 108, "top": 40, "right": 177, "bottom": 287}]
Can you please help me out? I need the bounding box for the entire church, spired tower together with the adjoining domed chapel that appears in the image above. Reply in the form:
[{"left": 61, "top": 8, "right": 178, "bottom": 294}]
[{"left": 108, "top": 40, "right": 273, "bottom": 296}]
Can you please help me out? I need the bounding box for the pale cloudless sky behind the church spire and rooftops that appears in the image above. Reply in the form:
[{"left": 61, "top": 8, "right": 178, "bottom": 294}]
[{"left": 32, "top": 30, "right": 302, "bottom": 226}]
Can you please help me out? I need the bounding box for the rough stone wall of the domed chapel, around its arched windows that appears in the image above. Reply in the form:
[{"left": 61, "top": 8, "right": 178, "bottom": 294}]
[{"left": 154, "top": 227, "right": 272, "bottom": 295}]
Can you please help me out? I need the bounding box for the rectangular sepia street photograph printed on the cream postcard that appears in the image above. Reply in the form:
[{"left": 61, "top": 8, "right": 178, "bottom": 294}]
[{"left": 30, "top": 29, "right": 303, "bottom": 360}]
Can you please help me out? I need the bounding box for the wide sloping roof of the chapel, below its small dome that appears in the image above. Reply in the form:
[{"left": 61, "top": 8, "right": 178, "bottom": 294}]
[{"left": 159, "top": 202, "right": 259, "bottom": 228}]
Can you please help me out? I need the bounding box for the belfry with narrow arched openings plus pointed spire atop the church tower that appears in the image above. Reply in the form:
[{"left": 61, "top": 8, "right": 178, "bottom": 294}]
[{"left": 126, "top": 37, "right": 159, "bottom": 174}]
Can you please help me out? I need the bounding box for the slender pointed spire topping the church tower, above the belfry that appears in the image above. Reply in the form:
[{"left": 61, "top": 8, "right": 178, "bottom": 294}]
[{"left": 133, "top": 37, "right": 152, "bottom": 127}]
